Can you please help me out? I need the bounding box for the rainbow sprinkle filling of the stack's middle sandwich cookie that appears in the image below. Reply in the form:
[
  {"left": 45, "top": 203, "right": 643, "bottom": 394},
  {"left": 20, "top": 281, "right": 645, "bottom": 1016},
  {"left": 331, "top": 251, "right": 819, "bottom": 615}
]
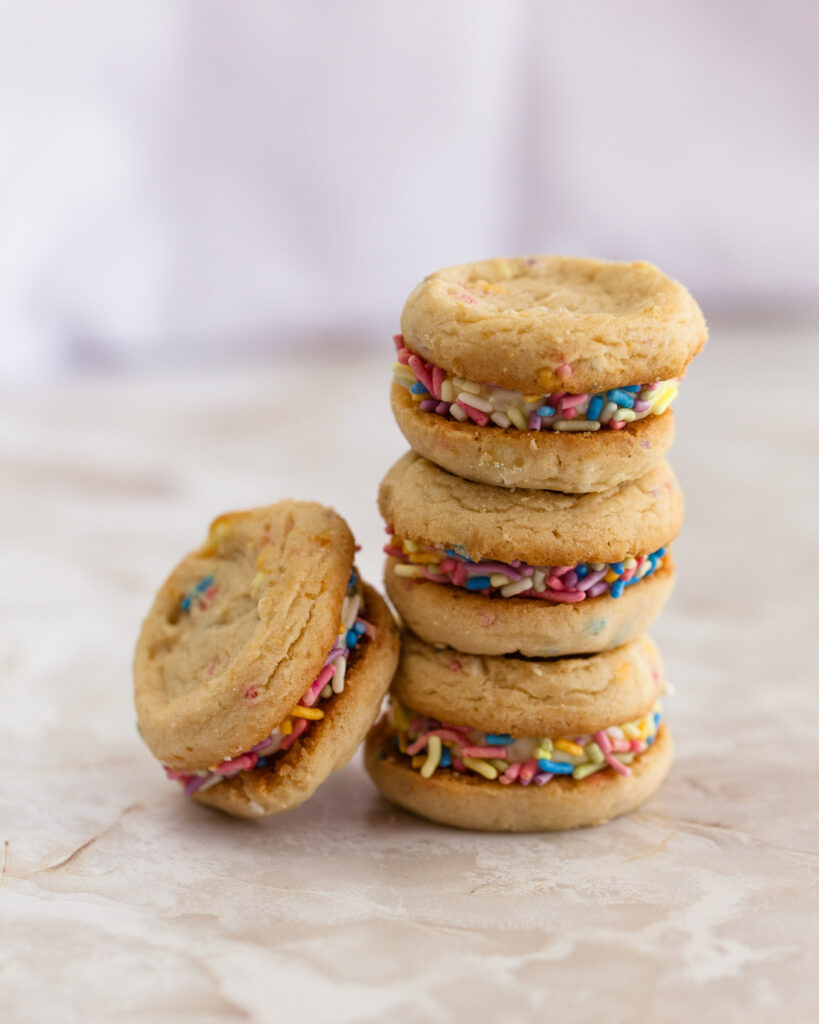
[{"left": 384, "top": 526, "right": 665, "bottom": 604}]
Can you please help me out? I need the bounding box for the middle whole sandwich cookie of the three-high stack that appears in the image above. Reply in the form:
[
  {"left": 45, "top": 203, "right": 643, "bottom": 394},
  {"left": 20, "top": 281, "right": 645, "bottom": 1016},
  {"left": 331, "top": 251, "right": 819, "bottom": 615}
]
[{"left": 379, "top": 452, "right": 683, "bottom": 657}]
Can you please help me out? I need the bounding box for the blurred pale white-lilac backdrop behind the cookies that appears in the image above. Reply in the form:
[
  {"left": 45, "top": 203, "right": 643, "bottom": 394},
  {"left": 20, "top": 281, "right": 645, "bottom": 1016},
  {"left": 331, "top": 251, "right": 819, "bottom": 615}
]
[{"left": 0, "top": 0, "right": 819, "bottom": 380}]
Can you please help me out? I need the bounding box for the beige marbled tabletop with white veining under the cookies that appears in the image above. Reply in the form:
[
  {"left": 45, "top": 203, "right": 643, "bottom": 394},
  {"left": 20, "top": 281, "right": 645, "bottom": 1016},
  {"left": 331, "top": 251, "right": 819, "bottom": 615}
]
[{"left": 0, "top": 329, "right": 819, "bottom": 1024}]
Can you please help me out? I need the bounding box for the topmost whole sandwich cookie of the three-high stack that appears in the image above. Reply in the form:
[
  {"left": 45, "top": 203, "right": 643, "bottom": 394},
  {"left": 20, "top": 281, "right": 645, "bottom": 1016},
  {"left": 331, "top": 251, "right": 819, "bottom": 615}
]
[{"left": 392, "top": 256, "right": 707, "bottom": 493}]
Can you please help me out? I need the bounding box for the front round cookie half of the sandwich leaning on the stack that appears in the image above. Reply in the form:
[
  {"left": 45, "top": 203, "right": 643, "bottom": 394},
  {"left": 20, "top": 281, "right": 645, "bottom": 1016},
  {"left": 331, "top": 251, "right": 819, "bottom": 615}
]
[{"left": 134, "top": 501, "right": 354, "bottom": 769}]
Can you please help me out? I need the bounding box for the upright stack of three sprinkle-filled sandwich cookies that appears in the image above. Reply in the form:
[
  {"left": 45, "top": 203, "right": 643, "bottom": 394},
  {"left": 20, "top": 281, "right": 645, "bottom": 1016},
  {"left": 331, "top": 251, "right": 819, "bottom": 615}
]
[{"left": 367, "top": 257, "right": 706, "bottom": 831}]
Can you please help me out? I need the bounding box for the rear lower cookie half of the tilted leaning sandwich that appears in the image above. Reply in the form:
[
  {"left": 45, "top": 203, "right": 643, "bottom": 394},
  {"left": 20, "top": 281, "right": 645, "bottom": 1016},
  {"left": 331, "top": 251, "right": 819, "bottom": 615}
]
[{"left": 192, "top": 584, "right": 399, "bottom": 818}]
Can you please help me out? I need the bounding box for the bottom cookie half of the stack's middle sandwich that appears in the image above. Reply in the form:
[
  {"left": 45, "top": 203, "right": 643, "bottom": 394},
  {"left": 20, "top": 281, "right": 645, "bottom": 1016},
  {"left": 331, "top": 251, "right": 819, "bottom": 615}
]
[{"left": 384, "top": 554, "right": 675, "bottom": 657}]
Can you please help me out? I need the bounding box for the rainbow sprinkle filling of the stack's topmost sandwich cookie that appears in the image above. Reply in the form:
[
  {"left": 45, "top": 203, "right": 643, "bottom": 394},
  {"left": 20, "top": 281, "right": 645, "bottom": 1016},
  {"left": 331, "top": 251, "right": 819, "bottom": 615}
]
[{"left": 392, "top": 334, "right": 680, "bottom": 432}]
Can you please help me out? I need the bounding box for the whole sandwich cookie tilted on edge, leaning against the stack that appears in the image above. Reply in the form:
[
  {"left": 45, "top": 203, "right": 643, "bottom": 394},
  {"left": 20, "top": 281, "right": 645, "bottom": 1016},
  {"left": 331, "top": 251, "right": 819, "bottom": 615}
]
[{"left": 134, "top": 501, "right": 398, "bottom": 817}]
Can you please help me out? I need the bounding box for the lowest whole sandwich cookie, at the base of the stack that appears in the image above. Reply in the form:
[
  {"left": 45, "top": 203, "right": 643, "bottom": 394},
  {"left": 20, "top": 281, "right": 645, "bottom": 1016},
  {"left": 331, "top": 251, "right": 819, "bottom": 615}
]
[{"left": 365, "top": 634, "right": 672, "bottom": 831}]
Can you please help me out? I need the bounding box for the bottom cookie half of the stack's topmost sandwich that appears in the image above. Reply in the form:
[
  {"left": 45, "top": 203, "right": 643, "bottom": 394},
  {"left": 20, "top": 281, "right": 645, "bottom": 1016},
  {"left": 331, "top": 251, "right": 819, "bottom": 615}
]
[{"left": 391, "top": 384, "right": 674, "bottom": 494}]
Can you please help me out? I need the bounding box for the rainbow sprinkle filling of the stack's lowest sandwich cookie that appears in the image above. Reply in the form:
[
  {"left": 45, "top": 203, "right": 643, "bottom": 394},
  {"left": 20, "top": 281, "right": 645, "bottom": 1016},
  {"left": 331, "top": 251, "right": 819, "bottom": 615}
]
[{"left": 389, "top": 696, "right": 662, "bottom": 785}]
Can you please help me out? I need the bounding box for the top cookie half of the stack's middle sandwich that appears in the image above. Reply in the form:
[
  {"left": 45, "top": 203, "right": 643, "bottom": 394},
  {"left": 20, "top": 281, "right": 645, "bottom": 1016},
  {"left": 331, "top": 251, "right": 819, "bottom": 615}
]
[{"left": 379, "top": 452, "right": 683, "bottom": 565}]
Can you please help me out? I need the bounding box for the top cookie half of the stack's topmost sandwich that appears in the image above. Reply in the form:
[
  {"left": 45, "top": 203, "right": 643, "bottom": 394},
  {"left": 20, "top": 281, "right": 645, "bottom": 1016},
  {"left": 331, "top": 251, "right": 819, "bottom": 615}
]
[{"left": 401, "top": 256, "right": 707, "bottom": 393}]
